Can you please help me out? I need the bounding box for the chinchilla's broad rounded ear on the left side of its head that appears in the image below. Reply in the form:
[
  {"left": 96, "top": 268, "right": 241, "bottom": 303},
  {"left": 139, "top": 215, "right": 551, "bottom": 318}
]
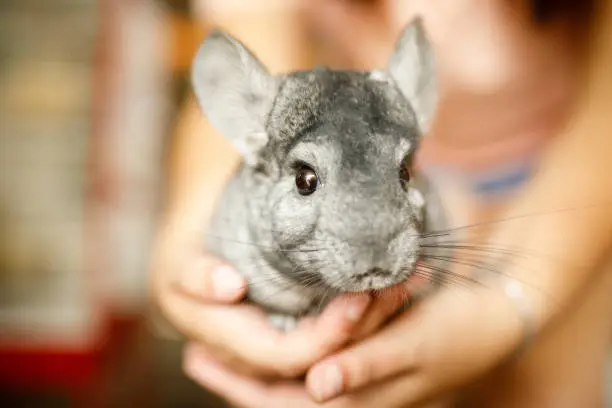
[{"left": 191, "top": 29, "right": 277, "bottom": 164}]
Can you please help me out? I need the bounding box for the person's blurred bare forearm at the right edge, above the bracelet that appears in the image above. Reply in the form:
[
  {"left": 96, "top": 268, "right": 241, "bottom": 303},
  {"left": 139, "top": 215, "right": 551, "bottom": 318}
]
[{"left": 498, "top": 2, "right": 612, "bottom": 318}]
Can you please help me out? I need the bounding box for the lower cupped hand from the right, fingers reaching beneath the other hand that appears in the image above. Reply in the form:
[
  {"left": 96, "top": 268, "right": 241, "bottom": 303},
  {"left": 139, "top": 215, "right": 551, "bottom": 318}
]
[{"left": 184, "top": 268, "right": 540, "bottom": 408}]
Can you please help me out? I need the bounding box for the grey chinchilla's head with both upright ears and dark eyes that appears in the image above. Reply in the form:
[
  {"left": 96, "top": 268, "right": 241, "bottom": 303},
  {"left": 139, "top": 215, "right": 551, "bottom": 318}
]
[{"left": 192, "top": 18, "right": 437, "bottom": 292}]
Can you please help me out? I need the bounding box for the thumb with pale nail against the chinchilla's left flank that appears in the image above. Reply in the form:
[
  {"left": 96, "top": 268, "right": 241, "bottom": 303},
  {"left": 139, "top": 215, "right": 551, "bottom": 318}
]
[{"left": 174, "top": 256, "right": 247, "bottom": 302}]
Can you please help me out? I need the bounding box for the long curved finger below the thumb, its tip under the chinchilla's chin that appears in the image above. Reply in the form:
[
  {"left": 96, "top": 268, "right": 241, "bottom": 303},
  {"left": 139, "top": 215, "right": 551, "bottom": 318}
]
[{"left": 163, "top": 293, "right": 369, "bottom": 377}]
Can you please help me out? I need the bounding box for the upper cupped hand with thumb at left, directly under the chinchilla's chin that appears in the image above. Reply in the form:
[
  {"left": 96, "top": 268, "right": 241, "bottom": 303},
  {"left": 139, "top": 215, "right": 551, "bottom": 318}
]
[{"left": 153, "top": 230, "right": 414, "bottom": 378}]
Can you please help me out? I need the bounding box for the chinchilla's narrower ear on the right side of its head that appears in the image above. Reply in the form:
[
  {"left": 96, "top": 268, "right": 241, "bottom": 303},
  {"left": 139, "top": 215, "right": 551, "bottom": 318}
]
[{"left": 387, "top": 17, "right": 437, "bottom": 133}]
